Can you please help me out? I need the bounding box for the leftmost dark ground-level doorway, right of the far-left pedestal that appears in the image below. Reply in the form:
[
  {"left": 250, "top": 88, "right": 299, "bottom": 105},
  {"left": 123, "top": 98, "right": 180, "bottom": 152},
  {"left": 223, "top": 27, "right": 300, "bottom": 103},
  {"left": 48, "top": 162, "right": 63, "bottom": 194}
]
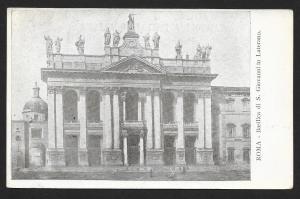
[{"left": 64, "top": 135, "right": 78, "bottom": 166}]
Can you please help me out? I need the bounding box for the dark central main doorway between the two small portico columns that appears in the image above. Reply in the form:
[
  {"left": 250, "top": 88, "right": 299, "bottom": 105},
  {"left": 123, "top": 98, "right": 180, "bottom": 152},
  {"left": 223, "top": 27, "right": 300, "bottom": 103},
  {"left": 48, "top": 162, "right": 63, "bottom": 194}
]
[{"left": 127, "top": 135, "right": 140, "bottom": 165}]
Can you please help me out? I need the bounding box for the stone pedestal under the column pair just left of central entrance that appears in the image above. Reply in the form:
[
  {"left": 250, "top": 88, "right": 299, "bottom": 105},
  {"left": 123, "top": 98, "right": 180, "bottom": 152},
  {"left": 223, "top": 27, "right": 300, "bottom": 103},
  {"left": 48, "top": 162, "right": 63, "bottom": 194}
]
[{"left": 102, "top": 149, "right": 123, "bottom": 166}]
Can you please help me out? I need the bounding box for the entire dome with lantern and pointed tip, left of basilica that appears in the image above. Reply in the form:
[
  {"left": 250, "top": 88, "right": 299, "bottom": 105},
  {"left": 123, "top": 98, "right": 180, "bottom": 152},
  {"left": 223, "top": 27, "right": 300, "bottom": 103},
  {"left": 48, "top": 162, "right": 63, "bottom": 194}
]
[{"left": 23, "top": 83, "right": 48, "bottom": 114}]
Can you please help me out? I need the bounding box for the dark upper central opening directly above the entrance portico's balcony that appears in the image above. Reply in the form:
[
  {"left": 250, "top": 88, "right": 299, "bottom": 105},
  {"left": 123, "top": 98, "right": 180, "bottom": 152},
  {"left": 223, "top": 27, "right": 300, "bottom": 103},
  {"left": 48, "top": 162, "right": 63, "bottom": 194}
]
[{"left": 126, "top": 92, "right": 139, "bottom": 120}]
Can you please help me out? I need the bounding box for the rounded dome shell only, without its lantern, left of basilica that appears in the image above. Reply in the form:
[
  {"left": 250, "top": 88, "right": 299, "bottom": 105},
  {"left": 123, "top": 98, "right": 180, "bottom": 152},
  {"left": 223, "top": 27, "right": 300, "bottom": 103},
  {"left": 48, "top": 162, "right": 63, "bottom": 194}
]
[{"left": 23, "top": 97, "right": 48, "bottom": 114}]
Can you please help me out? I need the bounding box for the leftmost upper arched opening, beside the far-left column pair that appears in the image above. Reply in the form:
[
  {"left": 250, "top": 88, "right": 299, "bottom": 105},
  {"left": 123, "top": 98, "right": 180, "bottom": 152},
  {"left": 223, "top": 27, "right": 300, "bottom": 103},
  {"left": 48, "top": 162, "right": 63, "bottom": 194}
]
[{"left": 63, "top": 90, "right": 78, "bottom": 122}]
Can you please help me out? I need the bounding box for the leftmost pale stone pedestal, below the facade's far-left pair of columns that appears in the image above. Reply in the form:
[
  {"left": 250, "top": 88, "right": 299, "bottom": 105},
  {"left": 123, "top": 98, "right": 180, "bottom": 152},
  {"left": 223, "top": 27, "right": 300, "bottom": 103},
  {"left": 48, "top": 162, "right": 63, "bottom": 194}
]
[{"left": 46, "top": 148, "right": 66, "bottom": 166}]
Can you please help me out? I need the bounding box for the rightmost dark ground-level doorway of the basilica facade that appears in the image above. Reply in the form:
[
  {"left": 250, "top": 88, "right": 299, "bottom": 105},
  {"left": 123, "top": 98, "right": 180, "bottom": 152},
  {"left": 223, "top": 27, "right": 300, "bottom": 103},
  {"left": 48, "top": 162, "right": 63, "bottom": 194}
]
[{"left": 184, "top": 136, "right": 196, "bottom": 165}]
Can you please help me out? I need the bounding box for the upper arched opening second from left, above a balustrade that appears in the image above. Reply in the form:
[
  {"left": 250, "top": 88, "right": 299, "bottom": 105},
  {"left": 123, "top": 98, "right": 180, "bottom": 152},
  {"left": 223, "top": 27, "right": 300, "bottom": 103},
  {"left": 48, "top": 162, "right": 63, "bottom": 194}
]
[{"left": 86, "top": 91, "right": 100, "bottom": 123}]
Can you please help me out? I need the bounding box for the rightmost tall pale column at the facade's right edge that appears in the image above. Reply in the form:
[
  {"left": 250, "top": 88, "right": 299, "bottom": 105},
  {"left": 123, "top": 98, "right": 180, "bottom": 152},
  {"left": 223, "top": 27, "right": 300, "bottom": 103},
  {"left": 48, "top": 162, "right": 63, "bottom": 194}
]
[{"left": 205, "top": 95, "right": 212, "bottom": 149}]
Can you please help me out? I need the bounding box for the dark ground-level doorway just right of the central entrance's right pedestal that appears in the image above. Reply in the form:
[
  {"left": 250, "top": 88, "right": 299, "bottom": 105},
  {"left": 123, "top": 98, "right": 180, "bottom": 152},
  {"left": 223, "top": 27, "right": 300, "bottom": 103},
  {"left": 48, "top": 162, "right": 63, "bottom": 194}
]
[{"left": 164, "top": 135, "right": 176, "bottom": 165}]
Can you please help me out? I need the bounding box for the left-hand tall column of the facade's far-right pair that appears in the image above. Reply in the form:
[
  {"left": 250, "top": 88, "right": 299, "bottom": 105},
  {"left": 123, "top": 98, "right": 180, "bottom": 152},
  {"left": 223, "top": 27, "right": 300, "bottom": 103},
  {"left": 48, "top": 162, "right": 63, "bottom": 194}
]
[{"left": 196, "top": 94, "right": 205, "bottom": 149}]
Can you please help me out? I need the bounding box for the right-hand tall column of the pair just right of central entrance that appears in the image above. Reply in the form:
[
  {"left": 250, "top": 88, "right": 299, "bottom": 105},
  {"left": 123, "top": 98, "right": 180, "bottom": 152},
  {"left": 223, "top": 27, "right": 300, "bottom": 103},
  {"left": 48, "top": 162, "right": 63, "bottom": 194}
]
[{"left": 154, "top": 90, "right": 161, "bottom": 149}]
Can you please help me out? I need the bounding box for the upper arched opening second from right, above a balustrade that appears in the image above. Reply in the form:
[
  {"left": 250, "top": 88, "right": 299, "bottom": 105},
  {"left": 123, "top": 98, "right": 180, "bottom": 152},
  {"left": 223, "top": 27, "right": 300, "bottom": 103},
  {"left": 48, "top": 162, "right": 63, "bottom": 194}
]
[{"left": 162, "top": 92, "right": 175, "bottom": 124}]
